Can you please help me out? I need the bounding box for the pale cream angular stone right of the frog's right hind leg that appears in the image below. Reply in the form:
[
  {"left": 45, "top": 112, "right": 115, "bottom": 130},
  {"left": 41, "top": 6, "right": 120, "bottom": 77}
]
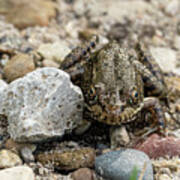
[{"left": 150, "top": 47, "right": 176, "bottom": 72}]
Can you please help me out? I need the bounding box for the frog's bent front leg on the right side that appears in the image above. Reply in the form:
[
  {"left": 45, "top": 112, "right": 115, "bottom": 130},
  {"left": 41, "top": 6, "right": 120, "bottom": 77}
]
[{"left": 143, "top": 97, "right": 165, "bottom": 130}]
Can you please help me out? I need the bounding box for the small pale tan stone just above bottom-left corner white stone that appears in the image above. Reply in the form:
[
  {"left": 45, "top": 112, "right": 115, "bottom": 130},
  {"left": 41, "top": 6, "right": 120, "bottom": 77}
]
[{"left": 0, "top": 149, "right": 22, "bottom": 169}]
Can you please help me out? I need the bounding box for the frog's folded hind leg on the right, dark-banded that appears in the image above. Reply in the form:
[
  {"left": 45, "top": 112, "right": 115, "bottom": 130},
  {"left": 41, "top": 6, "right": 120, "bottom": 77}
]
[{"left": 135, "top": 43, "right": 167, "bottom": 97}]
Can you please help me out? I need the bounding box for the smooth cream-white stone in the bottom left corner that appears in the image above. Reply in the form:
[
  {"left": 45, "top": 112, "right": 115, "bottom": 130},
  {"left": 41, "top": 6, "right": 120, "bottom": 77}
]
[{"left": 0, "top": 166, "right": 34, "bottom": 180}]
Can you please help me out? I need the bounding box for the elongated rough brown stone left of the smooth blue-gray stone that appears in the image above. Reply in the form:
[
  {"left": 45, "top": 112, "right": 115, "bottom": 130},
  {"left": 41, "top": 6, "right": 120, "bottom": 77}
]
[{"left": 36, "top": 148, "right": 95, "bottom": 171}]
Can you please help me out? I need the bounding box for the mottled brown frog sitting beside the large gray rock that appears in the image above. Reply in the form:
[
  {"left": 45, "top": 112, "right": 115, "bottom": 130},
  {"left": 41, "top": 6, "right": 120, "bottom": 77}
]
[{"left": 61, "top": 39, "right": 166, "bottom": 127}]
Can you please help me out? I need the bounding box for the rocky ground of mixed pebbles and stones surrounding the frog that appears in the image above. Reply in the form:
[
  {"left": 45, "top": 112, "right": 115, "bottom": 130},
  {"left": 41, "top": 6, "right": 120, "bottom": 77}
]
[{"left": 0, "top": 0, "right": 180, "bottom": 180}]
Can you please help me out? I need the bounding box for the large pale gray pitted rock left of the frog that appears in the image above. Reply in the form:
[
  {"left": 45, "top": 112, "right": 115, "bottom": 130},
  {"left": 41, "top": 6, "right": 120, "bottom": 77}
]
[{"left": 0, "top": 68, "right": 83, "bottom": 142}]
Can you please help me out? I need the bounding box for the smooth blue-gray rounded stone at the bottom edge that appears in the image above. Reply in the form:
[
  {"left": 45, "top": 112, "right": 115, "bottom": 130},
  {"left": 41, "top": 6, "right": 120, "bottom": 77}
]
[{"left": 95, "top": 149, "right": 153, "bottom": 180}]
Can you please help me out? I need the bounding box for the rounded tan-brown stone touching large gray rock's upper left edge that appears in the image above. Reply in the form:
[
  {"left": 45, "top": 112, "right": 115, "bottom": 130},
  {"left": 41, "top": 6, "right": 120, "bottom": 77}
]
[{"left": 4, "top": 54, "right": 35, "bottom": 82}]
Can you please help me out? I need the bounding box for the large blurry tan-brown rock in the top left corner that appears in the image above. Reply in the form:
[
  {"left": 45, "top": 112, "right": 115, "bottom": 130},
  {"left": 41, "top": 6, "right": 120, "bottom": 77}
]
[{"left": 0, "top": 0, "right": 56, "bottom": 28}]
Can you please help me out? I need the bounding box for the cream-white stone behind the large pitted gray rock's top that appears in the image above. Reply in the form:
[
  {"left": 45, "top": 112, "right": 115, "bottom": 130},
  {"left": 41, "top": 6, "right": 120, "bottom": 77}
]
[{"left": 38, "top": 42, "right": 71, "bottom": 62}]
